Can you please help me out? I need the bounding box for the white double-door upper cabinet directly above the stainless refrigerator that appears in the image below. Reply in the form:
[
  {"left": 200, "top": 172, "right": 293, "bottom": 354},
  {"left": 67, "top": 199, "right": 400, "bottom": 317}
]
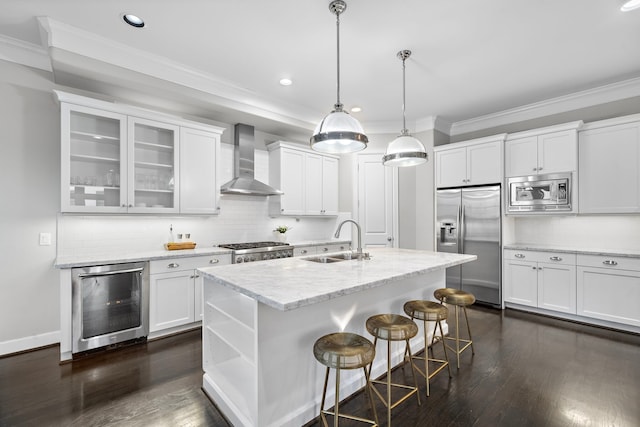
[{"left": 434, "top": 134, "right": 506, "bottom": 188}]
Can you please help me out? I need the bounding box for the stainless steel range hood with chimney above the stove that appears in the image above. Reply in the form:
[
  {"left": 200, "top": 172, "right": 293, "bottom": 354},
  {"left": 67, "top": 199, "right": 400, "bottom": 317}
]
[{"left": 220, "top": 123, "right": 283, "bottom": 196}]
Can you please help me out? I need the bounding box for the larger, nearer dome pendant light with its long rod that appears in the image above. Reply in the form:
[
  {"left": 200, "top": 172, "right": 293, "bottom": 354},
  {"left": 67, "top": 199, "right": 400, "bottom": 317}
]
[{"left": 310, "top": 0, "right": 369, "bottom": 154}]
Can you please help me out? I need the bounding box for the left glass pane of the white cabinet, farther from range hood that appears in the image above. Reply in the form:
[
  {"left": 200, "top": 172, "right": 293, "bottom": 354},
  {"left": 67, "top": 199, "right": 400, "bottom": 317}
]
[{"left": 69, "top": 111, "right": 120, "bottom": 206}]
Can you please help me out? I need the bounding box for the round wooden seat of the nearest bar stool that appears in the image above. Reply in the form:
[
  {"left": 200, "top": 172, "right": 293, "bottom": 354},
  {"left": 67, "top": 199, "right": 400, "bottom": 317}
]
[{"left": 313, "top": 332, "right": 376, "bottom": 369}]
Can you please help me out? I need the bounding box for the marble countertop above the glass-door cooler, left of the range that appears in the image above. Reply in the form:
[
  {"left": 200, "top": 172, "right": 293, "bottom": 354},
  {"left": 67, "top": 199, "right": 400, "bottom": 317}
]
[{"left": 54, "top": 246, "right": 231, "bottom": 268}]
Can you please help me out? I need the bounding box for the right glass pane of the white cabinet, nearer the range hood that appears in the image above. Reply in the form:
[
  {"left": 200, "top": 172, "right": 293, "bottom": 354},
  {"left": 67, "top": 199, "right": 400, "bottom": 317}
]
[{"left": 133, "top": 123, "right": 176, "bottom": 208}]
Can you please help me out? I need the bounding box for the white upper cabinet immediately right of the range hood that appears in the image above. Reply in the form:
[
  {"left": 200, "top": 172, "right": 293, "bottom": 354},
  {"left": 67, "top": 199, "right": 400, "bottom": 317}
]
[{"left": 267, "top": 141, "right": 339, "bottom": 216}]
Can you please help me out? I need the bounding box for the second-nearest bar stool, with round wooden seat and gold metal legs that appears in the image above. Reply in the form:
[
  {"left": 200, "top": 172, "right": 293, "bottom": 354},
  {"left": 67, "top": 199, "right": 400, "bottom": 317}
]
[{"left": 366, "top": 314, "right": 420, "bottom": 427}]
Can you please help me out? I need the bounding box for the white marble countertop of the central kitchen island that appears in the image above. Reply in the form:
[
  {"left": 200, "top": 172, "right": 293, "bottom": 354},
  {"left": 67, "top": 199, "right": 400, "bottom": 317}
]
[{"left": 199, "top": 248, "right": 477, "bottom": 311}]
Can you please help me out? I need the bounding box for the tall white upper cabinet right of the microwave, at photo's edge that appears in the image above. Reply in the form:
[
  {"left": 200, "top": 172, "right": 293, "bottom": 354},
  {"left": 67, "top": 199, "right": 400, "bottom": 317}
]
[{"left": 579, "top": 115, "right": 640, "bottom": 214}]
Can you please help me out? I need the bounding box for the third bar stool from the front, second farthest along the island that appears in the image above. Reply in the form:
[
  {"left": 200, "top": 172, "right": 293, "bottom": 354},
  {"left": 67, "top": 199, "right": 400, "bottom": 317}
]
[{"left": 403, "top": 300, "right": 451, "bottom": 396}]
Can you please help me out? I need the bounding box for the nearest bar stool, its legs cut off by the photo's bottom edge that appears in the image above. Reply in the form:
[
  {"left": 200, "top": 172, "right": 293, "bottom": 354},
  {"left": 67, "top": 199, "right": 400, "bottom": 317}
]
[{"left": 313, "top": 332, "right": 379, "bottom": 427}]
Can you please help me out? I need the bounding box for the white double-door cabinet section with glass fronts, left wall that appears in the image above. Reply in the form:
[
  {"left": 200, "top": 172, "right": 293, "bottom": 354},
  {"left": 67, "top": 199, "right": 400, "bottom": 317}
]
[{"left": 61, "top": 103, "right": 180, "bottom": 213}]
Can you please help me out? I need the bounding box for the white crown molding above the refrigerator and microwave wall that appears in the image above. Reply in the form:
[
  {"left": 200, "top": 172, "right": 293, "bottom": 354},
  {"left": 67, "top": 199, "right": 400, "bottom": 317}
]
[{"left": 450, "top": 77, "right": 640, "bottom": 136}]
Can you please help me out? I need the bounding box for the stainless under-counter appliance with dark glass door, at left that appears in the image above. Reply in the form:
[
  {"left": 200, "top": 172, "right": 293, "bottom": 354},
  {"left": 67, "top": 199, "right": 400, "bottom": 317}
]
[{"left": 71, "top": 262, "right": 149, "bottom": 353}]
